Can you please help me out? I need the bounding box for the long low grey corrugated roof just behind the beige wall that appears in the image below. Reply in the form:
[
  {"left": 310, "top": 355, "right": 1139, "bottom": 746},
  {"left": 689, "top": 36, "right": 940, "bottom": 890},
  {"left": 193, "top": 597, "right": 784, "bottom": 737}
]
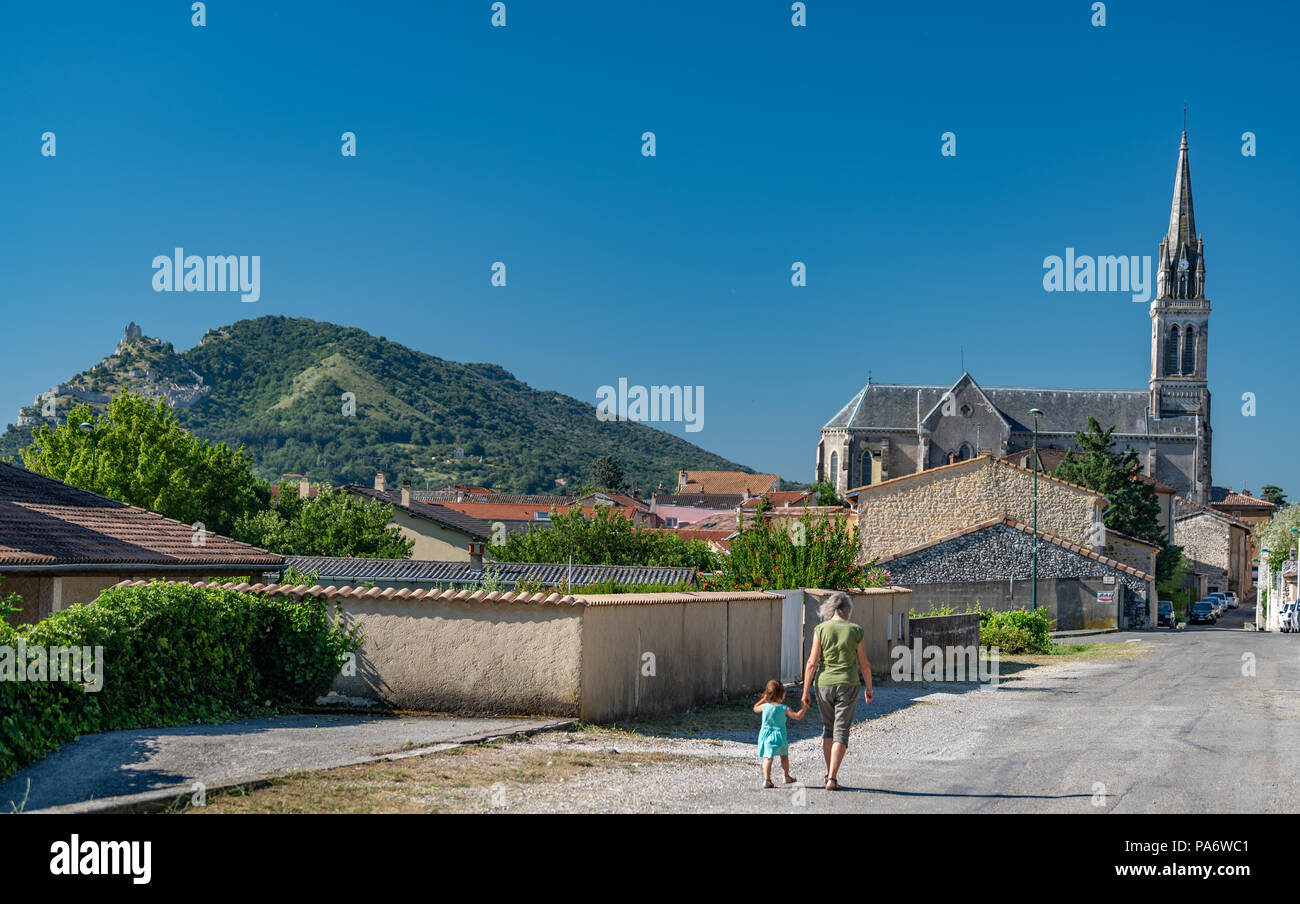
[{"left": 276, "top": 555, "right": 698, "bottom": 587}]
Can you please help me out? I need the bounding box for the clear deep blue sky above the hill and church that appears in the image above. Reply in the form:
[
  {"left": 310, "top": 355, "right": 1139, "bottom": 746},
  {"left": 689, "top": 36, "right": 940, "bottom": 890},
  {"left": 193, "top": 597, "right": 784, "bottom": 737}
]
[{"left": 0, "top": 0, "right": 1300, "bottom": 497}]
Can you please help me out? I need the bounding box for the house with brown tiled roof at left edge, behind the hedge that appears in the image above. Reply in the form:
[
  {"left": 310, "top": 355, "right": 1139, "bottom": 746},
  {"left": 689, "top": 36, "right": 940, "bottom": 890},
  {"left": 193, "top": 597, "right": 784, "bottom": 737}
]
[{"left": 0, "top": 463, "right": 285, "bottom": 624}]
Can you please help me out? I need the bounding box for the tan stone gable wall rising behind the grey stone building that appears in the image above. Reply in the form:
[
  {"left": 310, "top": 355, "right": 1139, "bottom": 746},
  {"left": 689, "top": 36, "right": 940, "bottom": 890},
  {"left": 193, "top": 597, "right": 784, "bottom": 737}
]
[{"left": 858, "top": 457, "right": 1105, "bottom": 562}]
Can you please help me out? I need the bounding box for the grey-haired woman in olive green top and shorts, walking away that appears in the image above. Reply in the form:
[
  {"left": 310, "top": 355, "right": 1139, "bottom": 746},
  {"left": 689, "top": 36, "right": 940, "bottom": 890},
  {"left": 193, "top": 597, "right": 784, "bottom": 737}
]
[{"left": 803, "top": 592, "right": 875, "bottom": 791}]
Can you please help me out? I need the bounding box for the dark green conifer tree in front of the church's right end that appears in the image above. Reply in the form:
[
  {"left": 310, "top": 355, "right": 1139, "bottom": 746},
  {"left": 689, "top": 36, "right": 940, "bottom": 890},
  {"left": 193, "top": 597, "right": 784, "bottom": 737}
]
[{"left": 1054, "top": 418, "right": 1182, "bottom": 580}]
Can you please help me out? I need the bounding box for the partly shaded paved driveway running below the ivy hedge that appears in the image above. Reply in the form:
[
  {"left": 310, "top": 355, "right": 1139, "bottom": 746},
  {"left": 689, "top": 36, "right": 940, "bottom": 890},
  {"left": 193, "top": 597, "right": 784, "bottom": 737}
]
[{"left": 0, "top": 713, "right": 569, "bottom": 813}]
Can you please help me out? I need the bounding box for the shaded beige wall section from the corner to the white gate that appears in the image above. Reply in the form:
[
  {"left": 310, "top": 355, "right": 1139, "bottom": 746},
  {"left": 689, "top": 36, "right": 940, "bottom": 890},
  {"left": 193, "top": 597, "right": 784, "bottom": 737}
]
[{"left": 581, "top": 593, "right": 783, "bottom": 722}]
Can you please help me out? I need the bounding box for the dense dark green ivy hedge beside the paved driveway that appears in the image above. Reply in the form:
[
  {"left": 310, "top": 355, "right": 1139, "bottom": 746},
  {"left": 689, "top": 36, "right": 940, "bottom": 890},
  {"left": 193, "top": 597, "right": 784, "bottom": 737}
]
[{"left": 0, "top": 583, "right": 360, "bottom": 779}]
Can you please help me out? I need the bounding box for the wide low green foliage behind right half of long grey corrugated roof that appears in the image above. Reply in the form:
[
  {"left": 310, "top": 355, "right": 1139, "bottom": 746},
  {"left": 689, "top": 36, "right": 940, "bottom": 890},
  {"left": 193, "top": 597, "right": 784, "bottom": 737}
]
[{"left": 488, "top": 506, "right": 718, "bottom": 571}]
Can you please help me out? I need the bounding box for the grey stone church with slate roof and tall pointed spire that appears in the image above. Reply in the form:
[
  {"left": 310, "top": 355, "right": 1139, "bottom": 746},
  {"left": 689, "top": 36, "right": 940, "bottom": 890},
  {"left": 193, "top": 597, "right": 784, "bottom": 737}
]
[{"left": 815, "top": 131, "right": 1212, "bottom": 505}]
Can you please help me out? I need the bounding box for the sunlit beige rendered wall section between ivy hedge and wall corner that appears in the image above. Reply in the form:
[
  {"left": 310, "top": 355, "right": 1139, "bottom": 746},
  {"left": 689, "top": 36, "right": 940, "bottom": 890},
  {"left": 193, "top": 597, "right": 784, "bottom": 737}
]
[{"left": 332, "top": 597, "right": 584, "bottom": 715}]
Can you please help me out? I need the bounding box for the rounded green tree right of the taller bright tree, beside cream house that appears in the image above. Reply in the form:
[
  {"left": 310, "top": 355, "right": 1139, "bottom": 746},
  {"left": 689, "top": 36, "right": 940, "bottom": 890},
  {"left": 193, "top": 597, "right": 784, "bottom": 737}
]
[{"left": 233, "top": 483, "right": 415, "bottom": 559}]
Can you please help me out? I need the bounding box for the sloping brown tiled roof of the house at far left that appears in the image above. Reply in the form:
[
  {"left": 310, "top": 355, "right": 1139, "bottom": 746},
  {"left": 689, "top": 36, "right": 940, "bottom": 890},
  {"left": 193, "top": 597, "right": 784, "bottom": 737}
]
[{"left": 0, "top": 463, "right": 283, "bottom": 571}]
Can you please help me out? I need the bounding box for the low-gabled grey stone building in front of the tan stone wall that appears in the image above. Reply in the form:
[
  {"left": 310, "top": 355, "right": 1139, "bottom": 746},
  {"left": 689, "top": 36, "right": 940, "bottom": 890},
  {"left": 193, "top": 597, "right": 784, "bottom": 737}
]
[{"left": 879, "top": 516, "right": 1156, "bottom": 631}]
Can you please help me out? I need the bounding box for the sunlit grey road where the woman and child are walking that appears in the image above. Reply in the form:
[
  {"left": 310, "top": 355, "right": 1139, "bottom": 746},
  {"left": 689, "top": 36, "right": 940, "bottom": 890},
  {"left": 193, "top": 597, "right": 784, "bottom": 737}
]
[{"left": 488, "top": 607, "right": 1300, "bottom": 813}]
